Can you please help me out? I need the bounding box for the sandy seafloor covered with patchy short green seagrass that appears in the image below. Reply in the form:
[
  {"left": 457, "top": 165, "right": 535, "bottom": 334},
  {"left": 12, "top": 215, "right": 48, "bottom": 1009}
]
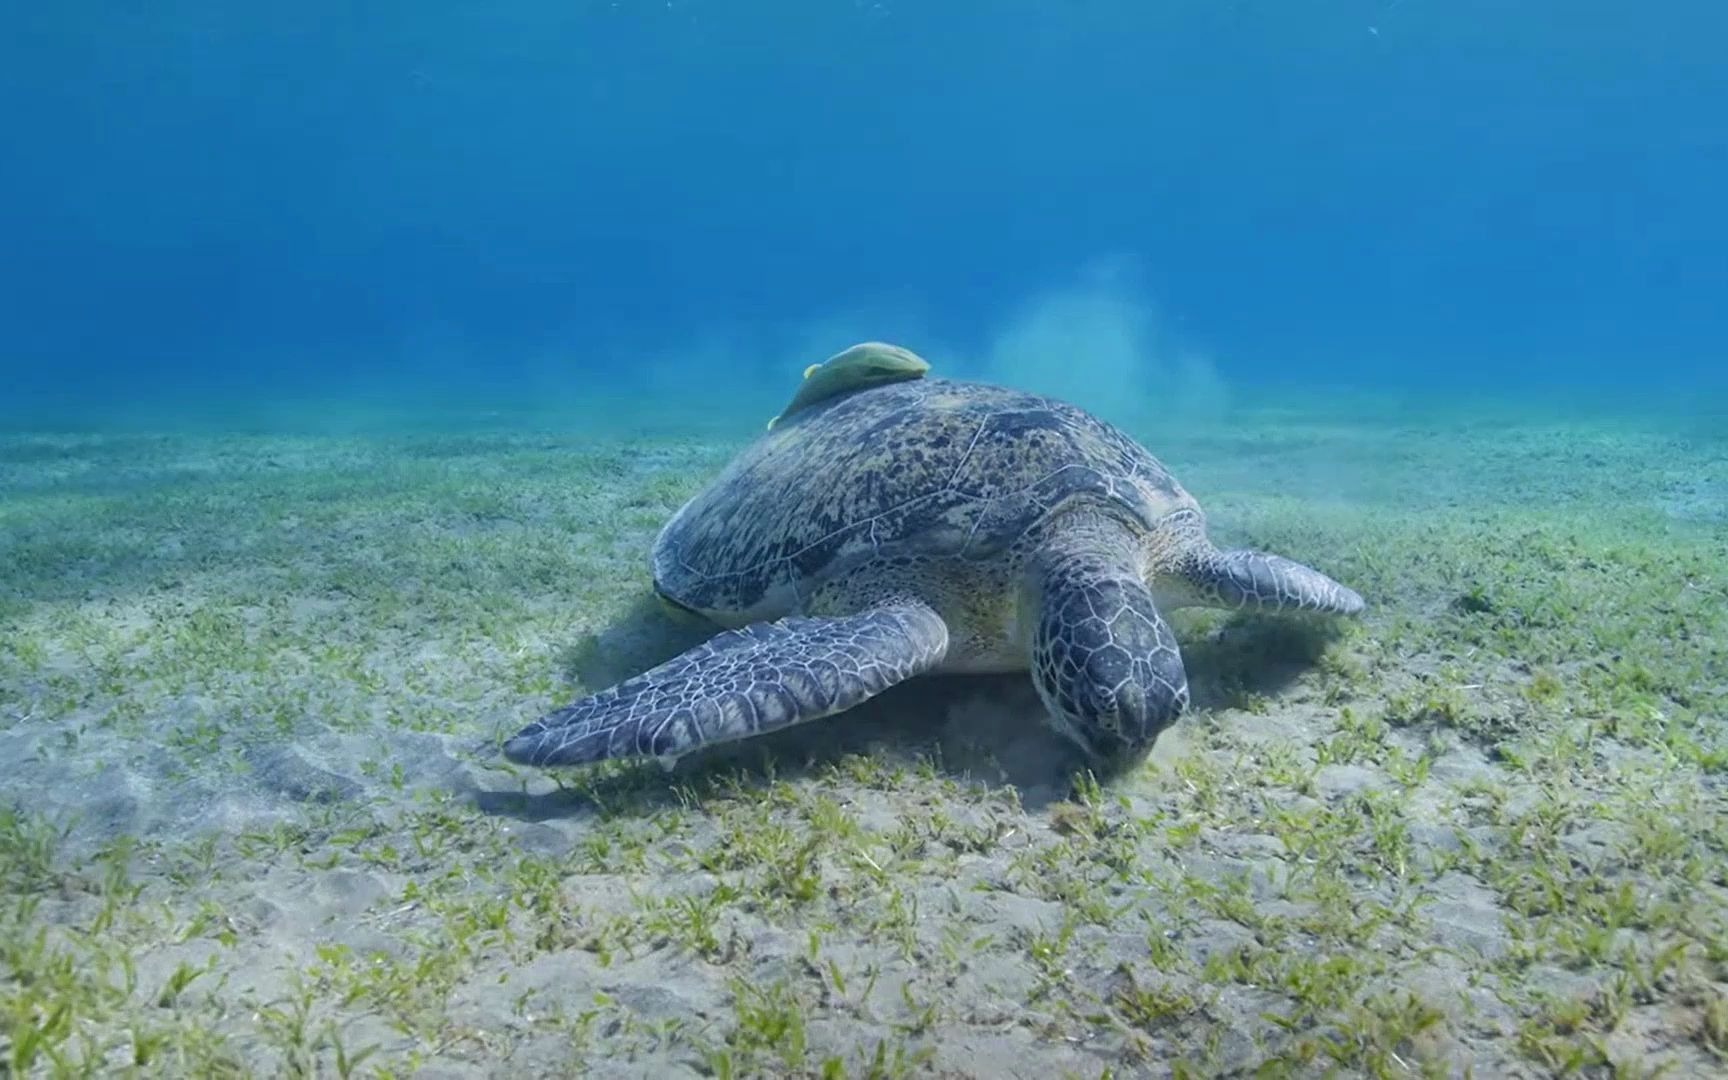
[{"left": 0, "top": 388, "right": 1728, "bottom": 1080}]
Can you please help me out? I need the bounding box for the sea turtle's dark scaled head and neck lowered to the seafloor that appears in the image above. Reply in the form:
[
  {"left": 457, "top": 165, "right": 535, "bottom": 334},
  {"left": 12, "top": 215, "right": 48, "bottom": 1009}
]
[{"left": 1023, "top": 515, "right": 1189, "bottom": 771}]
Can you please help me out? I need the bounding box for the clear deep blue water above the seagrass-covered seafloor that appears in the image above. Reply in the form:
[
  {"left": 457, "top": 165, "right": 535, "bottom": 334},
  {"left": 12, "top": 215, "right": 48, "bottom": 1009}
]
[{"left": 0, "top": 0, "right": 1728, "bottom": 418}]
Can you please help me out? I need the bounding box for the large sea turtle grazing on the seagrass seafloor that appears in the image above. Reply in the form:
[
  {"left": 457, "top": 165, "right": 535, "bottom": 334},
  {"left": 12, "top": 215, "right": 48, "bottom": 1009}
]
[{"left": 503, "top": 340, "right": 1363, "bottom": 769}]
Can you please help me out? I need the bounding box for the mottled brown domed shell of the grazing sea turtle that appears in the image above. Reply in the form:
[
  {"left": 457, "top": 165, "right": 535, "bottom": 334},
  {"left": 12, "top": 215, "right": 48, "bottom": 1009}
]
[{"left": 653, "top": 378, "right": 1194, "bottom": 612}]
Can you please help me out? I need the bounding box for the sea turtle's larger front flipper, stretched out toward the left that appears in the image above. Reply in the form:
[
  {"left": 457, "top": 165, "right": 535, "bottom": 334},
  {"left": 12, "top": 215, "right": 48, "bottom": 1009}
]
[{"left": 505, "top": 600, "right": 949, "bottom": 766}]
